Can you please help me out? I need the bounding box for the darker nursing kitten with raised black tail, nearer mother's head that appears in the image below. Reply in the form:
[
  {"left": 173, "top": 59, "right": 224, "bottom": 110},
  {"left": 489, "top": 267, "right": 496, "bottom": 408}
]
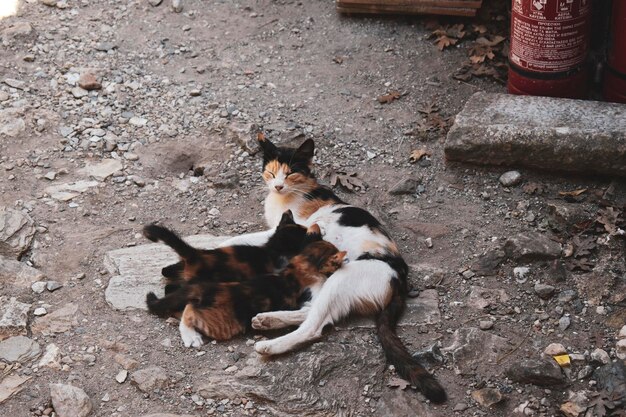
[{"left": 143, "top": 210, "right": 310, "bottom": 308}]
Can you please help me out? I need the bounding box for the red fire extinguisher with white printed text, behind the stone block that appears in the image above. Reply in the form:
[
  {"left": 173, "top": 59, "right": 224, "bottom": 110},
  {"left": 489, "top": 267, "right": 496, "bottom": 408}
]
[{"left": 508, "top": 0, "right": 592, "bottom": 98}]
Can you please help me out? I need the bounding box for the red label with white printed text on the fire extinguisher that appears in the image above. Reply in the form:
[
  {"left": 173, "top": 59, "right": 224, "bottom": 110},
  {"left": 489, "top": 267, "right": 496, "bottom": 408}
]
[{"left": 509, "top": 0, "right": 591, "bottom": 72}]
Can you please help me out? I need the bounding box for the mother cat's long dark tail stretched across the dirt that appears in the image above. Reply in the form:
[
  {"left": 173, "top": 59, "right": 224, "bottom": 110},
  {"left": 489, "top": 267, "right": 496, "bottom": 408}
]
[{"left": 376, "top": 278, "right": 447, "bottom": 403}]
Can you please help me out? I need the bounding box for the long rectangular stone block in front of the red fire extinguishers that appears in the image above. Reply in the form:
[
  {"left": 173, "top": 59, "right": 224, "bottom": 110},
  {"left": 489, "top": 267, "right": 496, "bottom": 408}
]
[{"left": 444, "top": 92, "right": 626, "bottom": 176}]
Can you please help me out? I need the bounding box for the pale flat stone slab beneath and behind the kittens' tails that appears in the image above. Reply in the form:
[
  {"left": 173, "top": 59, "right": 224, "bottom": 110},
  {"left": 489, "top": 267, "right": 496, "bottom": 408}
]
[{"left": 104, "top": 235, "right": 229, "bottom": 310}]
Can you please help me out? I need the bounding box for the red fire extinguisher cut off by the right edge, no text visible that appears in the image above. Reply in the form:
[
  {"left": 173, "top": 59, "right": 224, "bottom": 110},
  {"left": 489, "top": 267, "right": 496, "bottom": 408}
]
[{"left": 604, "top": 0, "right": 626, "bottom": 103}]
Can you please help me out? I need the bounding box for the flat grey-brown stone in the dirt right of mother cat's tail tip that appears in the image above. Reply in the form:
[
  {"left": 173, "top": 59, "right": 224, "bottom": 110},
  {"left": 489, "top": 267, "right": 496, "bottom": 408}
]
[{"left": 442, "top": 327, "right": 508, "bottom": 375}]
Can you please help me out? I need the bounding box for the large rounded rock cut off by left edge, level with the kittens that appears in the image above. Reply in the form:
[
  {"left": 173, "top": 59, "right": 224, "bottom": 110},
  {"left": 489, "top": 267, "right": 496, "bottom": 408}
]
[{"left": 0, "top": 207, "right": 35, "bottom": 259}]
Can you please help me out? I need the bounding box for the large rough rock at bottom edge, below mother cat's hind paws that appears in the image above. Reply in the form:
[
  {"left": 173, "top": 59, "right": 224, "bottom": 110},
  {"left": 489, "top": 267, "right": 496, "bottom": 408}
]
[{"left": 196, "top": 340, "right": 386, "bottom": 416}]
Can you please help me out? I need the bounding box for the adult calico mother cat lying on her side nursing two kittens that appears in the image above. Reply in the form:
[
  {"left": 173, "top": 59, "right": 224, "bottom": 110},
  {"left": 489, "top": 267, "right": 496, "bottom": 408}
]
[{"left": 200, "top": 134, "right": 446, "bottom": 403}]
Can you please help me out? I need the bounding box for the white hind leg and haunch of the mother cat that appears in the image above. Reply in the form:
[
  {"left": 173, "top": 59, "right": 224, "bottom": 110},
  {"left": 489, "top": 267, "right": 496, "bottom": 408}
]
[{"left": 254, "top": 260, "right": 395, "bottom": 355}]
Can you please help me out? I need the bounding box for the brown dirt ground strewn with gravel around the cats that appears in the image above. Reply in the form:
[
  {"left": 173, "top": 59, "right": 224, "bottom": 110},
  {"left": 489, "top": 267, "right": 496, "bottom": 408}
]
[{"left": 0, "top": 0, "right": 626, "bottom": 417}]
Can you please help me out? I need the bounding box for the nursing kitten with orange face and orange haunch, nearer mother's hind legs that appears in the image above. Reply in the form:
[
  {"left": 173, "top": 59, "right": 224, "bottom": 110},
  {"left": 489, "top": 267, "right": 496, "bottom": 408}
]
[{"left": 147, "top": 225, "right": 346, "bottom": 347}]
